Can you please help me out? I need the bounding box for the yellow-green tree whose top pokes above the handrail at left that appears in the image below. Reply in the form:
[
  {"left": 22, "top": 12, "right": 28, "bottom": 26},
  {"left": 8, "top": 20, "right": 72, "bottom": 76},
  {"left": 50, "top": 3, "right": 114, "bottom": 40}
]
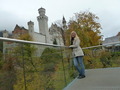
[{"left": 16, "top": 33, "right": 36, "bottom": 70}]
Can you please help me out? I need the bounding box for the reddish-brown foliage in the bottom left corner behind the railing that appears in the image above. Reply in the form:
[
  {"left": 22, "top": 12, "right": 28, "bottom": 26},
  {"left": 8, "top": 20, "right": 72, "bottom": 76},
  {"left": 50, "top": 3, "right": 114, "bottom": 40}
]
[{"left": 0, "top": 55, "right": 17, "bottom": 90}]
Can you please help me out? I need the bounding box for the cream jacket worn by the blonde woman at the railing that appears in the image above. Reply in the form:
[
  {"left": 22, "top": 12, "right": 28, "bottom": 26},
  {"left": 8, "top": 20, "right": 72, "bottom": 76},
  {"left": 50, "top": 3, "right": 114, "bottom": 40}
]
[{"left": 69, "top": 38, "right": 84, "bottom": 57}]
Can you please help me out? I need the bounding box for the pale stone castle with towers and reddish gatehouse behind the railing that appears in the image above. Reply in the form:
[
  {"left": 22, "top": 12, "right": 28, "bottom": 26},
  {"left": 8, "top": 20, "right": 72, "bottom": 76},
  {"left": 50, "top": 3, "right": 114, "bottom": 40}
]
[{"left": 1, "top": 7, "right": 67, "bottom": 52}]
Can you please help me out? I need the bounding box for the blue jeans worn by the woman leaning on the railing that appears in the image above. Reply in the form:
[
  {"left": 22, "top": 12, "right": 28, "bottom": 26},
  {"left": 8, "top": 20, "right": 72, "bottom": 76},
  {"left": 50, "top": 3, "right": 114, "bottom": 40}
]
[{"left": 73, "top": 56, "right": 85, "bottom": 76}]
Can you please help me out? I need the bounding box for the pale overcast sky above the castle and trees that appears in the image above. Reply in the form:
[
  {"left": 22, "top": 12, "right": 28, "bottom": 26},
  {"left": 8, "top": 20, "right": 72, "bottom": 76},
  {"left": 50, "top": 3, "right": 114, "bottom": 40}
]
[{"left": 0, "top": 0, "right": 120, "bottom": 38}]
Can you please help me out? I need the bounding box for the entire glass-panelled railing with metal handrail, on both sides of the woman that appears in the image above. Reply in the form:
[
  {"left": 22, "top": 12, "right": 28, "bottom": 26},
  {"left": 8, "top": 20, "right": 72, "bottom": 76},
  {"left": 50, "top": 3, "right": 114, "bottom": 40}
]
[{"left": 0, "top": 37, "right": 120, "bottom": 90}]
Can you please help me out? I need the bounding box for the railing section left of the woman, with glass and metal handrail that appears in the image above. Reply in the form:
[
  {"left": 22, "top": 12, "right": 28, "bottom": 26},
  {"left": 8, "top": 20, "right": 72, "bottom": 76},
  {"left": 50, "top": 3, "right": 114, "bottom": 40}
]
[{"left": 0, "top": 37, "right": 72, "bottom": 90}]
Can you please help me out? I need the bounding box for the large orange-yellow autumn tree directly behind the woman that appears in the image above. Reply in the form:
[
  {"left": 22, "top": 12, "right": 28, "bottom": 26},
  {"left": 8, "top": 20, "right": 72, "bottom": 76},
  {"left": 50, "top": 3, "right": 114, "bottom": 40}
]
[{"left": 66, "top": 11, "right": 102, "bottom": 47}]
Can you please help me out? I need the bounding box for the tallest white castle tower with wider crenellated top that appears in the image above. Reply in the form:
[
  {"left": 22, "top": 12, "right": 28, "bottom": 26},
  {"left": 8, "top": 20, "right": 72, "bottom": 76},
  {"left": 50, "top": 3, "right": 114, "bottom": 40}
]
[{"left": 37, "top": 8, "right": 50, "bottom": 43}]
